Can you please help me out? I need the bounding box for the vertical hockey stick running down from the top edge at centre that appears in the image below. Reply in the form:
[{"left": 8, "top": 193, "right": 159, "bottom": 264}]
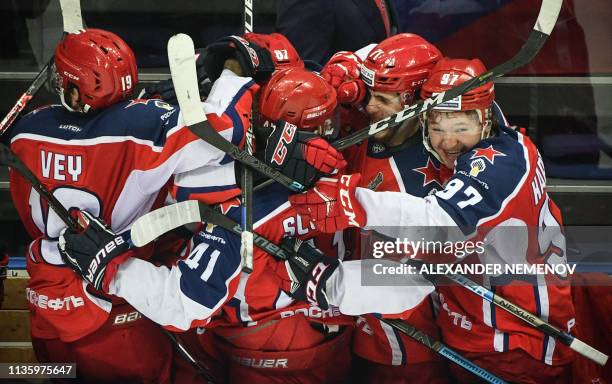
[{"left": 240, "top": 0, "right": 255, "bottom": 273}]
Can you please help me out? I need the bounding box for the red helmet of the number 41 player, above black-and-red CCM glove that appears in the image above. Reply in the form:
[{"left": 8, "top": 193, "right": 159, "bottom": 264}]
[{"left": 259, "top": 68, "right": 338, "bottom": 129}]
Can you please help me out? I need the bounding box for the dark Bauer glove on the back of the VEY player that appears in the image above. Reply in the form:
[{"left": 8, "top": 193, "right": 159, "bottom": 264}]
[{"left": 57, "top": 211, "right": 130, "bottom": 292}]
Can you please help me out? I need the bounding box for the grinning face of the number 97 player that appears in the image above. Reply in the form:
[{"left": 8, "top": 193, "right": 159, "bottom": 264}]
[{"left": 427, "top": 112, "right": 482, "bottom": 169}]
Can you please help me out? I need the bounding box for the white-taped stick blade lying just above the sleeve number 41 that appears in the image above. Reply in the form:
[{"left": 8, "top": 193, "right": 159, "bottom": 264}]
[{"left": 130, "top": 200, "right": 202, "bottom": 247}]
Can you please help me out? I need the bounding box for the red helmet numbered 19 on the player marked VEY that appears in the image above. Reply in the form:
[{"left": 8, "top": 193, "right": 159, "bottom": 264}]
[{"left": 55, "top": 29, "right": 138, "bottom": 112}]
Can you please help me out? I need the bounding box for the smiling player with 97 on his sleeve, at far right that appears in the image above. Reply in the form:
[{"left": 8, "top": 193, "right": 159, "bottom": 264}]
[{"left": 291, "top": 59, "right": 575, "bottom": 383}]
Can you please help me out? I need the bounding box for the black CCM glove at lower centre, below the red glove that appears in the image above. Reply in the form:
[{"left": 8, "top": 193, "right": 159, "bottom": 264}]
[{"left": 281, "top": 238, "right": 339, "bottom": 310}]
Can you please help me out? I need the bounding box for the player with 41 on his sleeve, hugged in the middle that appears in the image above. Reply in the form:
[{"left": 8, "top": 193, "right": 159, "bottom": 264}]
[{"left": 56, "top": 69, "right": 431, "bottom": 383}]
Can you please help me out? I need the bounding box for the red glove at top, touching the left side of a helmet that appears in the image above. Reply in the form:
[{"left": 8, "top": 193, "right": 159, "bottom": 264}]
[{"left": 321, "top": 51, "right": 366, "bottom": 105}]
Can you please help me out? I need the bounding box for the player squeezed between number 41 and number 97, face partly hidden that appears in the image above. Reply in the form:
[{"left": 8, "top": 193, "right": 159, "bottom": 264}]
[{"left": 322, "top": 33, "right": 450, "bottom": 383}]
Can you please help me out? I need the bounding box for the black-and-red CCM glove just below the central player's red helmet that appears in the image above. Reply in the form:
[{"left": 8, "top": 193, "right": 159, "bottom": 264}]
[{"left": 265, "top": 120, "right": 346, "bottom": 186}]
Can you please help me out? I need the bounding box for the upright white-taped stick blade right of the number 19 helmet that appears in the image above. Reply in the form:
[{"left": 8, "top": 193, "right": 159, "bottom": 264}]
[{"left": 168, "top": 33, "right": 206, "bottom": 126}]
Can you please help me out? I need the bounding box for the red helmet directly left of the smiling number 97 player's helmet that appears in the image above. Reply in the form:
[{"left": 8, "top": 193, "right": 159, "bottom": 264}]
[{"left": 361, "top": 33, "right": 442, "bottom": 106}]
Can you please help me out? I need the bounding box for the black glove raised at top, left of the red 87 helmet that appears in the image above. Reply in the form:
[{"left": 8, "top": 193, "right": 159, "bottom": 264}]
[{"left": 204, "top": 35, "right": 275, "bottom": 83}]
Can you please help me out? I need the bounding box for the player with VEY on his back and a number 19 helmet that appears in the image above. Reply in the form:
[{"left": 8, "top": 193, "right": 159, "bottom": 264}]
[{"left": 9, "top": 29, "right": 268, "bottom": 382}]
